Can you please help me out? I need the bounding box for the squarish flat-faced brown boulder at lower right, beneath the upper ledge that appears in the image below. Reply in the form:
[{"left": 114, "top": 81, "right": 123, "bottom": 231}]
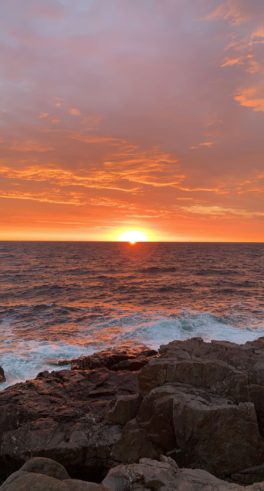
[{"left": 173, "top": 391, "right": 264, "bottom": 476}]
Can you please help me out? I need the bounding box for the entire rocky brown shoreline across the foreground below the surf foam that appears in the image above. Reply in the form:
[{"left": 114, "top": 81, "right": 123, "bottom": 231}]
[{"left": 0, "top": 338, "right": 264, "bottom": 491}]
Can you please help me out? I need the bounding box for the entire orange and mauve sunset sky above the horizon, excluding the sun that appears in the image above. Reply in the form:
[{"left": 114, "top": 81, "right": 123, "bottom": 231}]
[{"left": 0, "top": 0, "right": 264, "bottom": 241}]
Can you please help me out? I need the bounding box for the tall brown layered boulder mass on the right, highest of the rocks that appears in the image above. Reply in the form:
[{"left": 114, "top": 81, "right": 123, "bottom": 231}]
[{"left": 132, "top": 338, "right": 264, "bottom": 482}]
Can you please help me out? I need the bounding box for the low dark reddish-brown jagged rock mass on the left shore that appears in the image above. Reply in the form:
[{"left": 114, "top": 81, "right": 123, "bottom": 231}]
[{"left": 0, "top": 358, "right": 138, "bottom": 481}]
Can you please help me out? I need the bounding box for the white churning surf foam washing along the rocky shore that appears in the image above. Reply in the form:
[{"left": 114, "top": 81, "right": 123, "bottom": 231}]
[{"left": 1, "top": 311, "right": 264, "bottom": 389}]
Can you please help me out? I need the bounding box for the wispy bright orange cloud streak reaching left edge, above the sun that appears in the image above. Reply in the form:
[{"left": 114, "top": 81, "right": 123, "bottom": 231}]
[{"left": 0, "top": 140, "right": 185, "bottom": 193}]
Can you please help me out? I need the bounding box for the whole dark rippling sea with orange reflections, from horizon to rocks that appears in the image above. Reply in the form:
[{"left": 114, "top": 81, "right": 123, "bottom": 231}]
[{"left": 0, "top": 242, "right": 264, "bottom": 387}]
